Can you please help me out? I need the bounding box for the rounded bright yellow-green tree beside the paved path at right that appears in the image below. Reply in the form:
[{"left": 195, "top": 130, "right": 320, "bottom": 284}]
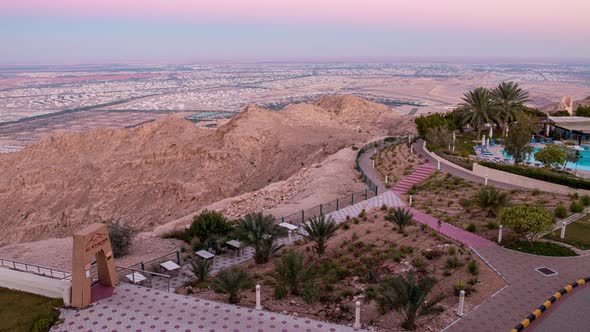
[{"left": 499, "top": 205, "right": 555, "bottom": 244}]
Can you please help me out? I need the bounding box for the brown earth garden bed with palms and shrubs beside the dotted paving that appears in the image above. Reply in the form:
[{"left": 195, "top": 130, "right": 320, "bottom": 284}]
[{"left": 179, "top": 208, "right": 504, "bottom": 331}]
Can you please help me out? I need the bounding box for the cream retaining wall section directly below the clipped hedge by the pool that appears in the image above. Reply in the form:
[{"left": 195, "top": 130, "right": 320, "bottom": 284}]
[{"left": 473, "top": 163, "right": 590, "bottom": 195}]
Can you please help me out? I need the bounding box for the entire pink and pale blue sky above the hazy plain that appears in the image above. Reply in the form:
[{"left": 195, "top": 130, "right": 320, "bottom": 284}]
[{"left": 0, "top": 0, "right": 590, "bottom": 65}]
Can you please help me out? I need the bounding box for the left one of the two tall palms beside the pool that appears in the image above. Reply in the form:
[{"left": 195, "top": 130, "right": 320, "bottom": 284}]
[{"left": 461, "top": 87, "right": 498, "bottom": 139}]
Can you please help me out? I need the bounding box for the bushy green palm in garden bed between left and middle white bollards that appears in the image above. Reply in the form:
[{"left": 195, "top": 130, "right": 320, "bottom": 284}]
[{"left": 273, "top": 250, "right": 313, "bottom": 295}]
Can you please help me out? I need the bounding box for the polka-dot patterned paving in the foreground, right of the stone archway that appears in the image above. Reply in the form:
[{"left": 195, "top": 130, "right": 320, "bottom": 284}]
[{"left": 51, "top": 284, "right": 354, "bottom": 332}]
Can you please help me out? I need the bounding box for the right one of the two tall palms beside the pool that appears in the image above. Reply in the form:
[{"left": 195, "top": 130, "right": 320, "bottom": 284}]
[{"left": 492, "top": 82, "right": 529, "bottom": 136}]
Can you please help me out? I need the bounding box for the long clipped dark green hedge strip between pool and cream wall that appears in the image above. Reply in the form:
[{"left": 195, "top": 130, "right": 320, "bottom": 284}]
[{"left": 480, "top": 161, "right": 590, "bottom": 190}]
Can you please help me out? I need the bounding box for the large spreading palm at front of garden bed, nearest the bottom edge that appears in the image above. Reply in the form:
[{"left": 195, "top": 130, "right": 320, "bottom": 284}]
[{"left": 376, "top": 272, "right": 445, "bottom": 330}]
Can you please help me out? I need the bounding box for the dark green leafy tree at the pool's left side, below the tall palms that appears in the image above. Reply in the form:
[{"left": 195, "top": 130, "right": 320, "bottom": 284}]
[{"left": 504, "top": 114, "right": 535, "bottom": 164}]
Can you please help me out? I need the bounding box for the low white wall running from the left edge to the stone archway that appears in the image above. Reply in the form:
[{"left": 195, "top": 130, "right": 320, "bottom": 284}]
[{"left": 0, "top": 267, "right": 72, "bottom": 306}]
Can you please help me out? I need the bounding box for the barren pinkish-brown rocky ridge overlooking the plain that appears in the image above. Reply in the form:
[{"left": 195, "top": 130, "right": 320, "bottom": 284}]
[{"left": 0, "top": 96, "right": 412, "bottom": 244}]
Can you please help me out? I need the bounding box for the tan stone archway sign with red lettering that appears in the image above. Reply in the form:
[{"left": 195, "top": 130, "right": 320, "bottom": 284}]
[{"left": 72, "top": 223, "right": 119, "bottom": 308}]
